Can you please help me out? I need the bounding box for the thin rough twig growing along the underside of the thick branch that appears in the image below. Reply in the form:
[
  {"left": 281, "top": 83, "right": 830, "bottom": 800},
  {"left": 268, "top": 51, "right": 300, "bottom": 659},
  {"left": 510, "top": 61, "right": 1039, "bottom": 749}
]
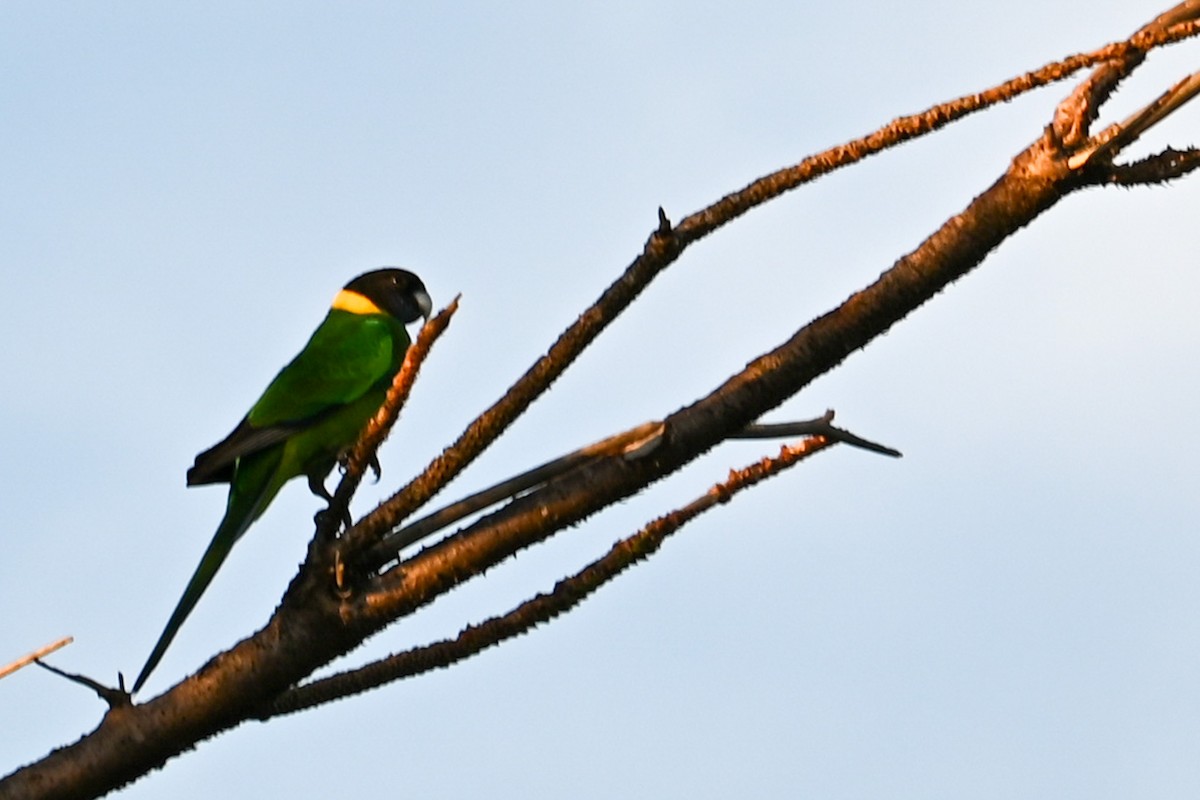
[{"left": 258, "top": 437, "right": 835, "bottom": 720}]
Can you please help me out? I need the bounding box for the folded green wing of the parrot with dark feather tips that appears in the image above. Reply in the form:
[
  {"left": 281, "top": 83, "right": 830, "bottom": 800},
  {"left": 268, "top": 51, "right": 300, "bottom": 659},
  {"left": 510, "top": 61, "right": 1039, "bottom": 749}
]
[{"left": 187, "top": 309, "right": 398, "bottom": 486}]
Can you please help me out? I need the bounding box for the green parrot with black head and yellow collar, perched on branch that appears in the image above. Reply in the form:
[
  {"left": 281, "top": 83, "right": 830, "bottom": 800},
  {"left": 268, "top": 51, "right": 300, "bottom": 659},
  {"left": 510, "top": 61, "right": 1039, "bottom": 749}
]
[{"left": 133, "top": 269, "right": 432, "bottom": 692}]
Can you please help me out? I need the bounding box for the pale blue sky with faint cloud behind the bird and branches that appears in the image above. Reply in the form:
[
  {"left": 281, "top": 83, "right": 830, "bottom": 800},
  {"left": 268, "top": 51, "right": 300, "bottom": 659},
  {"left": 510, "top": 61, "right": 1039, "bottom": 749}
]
[{"left": 0, "top": 0, "right": 1200, "bottom": 799}]
